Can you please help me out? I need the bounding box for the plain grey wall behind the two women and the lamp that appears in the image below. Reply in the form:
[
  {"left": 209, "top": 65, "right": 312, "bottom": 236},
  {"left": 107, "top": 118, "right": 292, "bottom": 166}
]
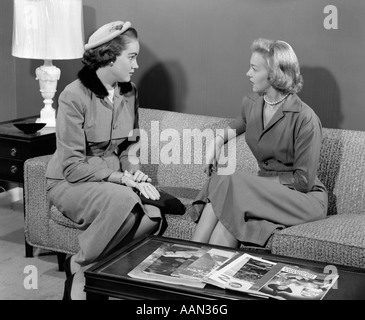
[{"left": 0, "top": 0, "right": 365, "bottom": 130}]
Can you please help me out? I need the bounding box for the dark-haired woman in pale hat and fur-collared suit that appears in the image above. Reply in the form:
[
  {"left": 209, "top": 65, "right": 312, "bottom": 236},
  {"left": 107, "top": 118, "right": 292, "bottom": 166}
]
[{"left": 46, "top": 21, "right": 161, "bottom": 299}]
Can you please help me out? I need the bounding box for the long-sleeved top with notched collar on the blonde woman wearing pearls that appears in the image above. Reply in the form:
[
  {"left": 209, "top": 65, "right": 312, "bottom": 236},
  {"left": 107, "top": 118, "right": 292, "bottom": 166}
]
[{"left": 229, "top": 94, "right": 325, "bottom": 192}]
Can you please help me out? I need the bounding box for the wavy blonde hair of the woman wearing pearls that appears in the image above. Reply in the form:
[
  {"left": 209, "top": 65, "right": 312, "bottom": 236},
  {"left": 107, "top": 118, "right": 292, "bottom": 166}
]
[{"left": 251, "top": 38, "right": 303, "bottom": 94}]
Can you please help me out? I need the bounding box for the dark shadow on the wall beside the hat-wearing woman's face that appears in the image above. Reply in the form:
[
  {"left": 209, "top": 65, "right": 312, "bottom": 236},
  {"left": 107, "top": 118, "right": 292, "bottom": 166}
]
[{"left": 137, "top": 44, "right": 187, "bottom": 112}]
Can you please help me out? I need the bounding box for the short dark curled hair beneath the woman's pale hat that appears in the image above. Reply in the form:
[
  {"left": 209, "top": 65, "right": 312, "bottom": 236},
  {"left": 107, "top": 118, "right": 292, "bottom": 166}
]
[{"left": 82, "top": 28, "right": 138, "bottom": 70}]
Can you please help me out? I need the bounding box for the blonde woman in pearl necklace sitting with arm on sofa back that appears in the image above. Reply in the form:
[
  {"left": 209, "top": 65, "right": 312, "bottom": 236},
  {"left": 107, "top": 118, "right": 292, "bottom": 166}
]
[{"left": 193, "top": 39, "right": 328, "bottom": 247}]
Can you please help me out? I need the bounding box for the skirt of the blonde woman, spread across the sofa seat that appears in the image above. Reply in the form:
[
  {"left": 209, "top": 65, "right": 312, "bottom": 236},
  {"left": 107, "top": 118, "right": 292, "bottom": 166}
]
[{"left": 192, "top": 172, "right": 328, "bottom": 246}]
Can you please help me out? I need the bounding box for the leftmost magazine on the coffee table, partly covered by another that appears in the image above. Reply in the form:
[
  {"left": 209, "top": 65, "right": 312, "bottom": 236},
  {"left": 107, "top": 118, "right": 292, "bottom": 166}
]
[{"left": 128, "top": 243, "right": 208, "bottom": 288}]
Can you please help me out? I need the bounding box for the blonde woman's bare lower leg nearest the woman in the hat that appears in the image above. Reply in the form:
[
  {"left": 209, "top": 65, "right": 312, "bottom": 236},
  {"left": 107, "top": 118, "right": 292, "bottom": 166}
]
[{"left": 192, "top": 202, "right": 218, "bottom": 243}]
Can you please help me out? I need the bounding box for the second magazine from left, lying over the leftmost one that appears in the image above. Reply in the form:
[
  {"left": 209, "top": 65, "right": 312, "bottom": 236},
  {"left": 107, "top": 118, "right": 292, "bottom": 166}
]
[{"left": 173, "top": 249, "right": 235, "bottom": 281}]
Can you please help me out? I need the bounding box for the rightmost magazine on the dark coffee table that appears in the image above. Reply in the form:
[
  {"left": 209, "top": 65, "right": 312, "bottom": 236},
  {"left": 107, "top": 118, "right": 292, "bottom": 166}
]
[{"left": 253, "top": 263, "right": 338, "bottom": 300}]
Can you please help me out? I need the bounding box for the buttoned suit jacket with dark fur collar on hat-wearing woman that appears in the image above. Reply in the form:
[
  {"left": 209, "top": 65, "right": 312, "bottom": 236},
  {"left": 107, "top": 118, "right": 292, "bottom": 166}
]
[{"left": 46, "top": 68, "right": 138, "bottom": 183}]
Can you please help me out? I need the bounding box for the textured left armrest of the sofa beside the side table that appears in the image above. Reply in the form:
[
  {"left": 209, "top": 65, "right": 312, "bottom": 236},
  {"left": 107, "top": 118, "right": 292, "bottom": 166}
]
[{"left": 24, "top": 155, "right": 52, "bottom": 245}]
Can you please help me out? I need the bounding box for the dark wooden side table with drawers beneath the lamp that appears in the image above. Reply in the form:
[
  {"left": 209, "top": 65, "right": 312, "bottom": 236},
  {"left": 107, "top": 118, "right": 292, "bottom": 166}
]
[{"left": 0, "top": 116, "right": 56, "bottom": 257}]
